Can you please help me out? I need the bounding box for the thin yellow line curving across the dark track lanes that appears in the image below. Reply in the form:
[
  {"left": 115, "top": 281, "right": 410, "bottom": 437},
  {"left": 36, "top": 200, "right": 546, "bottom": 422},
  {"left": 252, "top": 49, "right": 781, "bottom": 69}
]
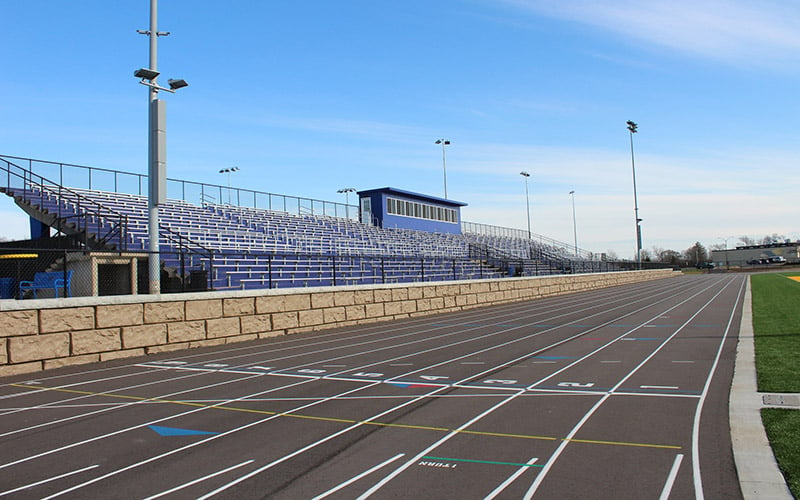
[{"left": 9, "top": 384, "right": 681, "bottom": 450}]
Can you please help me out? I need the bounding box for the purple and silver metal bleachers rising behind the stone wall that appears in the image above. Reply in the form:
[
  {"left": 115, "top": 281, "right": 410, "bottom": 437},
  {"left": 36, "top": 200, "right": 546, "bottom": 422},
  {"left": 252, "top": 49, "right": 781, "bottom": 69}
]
[{"left": 0, "top": 154, "right": 624, "bottom": 289}]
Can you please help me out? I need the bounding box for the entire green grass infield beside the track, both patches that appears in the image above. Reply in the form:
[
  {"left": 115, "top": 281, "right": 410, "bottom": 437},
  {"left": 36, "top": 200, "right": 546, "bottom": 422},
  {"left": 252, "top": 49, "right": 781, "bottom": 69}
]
[{"left": 750, "top": 273, "right": 800, "bottom": 498}]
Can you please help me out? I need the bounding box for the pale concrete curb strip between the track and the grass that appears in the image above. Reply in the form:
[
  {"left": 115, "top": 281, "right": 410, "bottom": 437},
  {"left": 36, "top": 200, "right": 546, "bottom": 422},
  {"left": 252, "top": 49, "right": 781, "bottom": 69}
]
[{"left": 730, "top": 280, "right": 800, "bottom": 500}]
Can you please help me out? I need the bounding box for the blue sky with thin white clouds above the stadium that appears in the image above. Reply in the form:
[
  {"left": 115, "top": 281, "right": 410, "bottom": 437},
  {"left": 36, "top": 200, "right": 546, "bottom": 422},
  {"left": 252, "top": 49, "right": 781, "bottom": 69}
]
[{"left": 0, "top": 0, "right": 800, "bottom": 258}]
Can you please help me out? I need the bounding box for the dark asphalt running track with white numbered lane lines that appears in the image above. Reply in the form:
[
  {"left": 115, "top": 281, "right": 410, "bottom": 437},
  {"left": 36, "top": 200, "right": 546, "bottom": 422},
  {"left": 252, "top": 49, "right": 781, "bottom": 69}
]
[{"left": 0, "top": 274, "right": 746, "bottom": 499}]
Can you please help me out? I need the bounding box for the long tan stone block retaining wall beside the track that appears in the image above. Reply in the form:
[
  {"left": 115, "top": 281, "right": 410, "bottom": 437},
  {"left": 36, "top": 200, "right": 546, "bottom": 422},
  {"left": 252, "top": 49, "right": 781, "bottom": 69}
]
[{"left": 0, "top": 269, "right": 674, "bottom": 376}]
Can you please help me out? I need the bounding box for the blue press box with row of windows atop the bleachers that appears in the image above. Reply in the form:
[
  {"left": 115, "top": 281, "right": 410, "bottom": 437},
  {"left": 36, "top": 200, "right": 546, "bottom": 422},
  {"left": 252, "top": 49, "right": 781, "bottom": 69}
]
[{"left": 358, "top": 187, "right": 467, "bottom": 234}]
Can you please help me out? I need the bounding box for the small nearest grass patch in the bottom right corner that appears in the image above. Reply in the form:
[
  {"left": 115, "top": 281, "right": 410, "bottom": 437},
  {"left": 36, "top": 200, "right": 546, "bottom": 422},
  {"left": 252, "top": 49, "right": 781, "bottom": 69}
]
[{"left": 761, "top": 408, "right": 800, "bottom": 498}]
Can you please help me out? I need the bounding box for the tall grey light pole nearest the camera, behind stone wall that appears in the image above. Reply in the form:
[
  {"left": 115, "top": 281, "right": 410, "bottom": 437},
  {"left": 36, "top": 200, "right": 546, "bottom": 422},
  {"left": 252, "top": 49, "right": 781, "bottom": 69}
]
[{"left": 133, "top": 0, "right": 189, "bottom": 294}]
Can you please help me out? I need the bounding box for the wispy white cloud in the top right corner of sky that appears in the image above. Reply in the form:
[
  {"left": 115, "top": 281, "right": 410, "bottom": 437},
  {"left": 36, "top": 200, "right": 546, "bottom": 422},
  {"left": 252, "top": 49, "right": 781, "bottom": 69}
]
[{"left": 496, "top": 0, "right": 800, "bottom": 67}]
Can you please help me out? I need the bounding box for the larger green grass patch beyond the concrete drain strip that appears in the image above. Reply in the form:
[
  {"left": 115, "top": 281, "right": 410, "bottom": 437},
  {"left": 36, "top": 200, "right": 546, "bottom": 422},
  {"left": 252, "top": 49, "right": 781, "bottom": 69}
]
[{"left": 750, "top": 273, "right": 800, "bottom": 392}]
